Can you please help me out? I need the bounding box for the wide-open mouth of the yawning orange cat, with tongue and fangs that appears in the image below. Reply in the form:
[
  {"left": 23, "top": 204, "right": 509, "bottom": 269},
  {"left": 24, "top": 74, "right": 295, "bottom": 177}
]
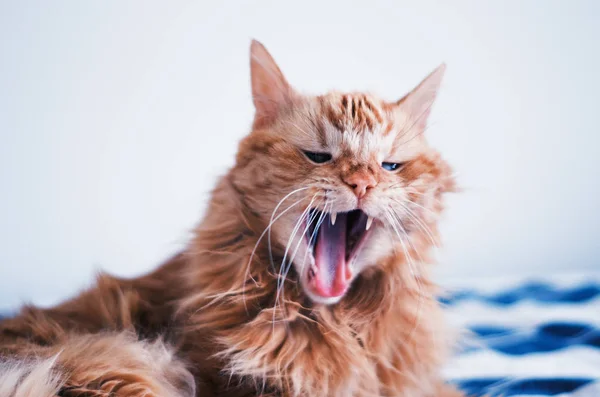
[{"left": 306, "top": 209, "right": 373, "bottom": 298}]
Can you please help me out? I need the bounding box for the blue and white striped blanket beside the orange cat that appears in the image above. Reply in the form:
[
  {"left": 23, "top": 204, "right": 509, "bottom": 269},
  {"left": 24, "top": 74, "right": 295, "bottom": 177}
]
[{"left": 443, "top": 275, "right": 600, "bottom": 397}]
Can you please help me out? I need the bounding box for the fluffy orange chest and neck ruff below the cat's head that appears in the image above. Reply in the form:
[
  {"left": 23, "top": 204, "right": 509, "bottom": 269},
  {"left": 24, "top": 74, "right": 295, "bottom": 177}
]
[{"left": 180, "top": 179, "right": 449, "bottom": 396}]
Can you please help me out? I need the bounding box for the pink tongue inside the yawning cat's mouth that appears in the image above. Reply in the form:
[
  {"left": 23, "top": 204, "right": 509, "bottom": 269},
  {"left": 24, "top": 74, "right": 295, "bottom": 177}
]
[{"left": 311, "top": 214, "right": 350, "bottom": 298}]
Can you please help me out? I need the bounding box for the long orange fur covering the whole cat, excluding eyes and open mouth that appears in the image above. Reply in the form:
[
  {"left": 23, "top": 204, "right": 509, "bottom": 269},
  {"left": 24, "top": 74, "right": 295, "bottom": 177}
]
[{"left": 0, "top": 42, "right": 461, "bottom": 397}]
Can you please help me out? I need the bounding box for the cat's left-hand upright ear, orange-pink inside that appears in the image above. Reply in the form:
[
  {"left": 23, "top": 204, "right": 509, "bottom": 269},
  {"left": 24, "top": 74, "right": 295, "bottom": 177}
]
[{"left": 250, "top": 40, "right": 294, "bottom": 127}]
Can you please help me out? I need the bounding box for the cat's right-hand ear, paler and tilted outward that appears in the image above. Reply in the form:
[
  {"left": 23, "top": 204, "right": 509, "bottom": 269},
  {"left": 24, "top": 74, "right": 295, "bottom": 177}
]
[{"left": 396, "top": 64, "right": 446, "bottom": 134}]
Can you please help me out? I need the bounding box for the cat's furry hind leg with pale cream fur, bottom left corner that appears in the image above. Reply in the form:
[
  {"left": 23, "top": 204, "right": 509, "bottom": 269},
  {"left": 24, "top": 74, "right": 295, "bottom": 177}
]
[{"left": 0, "top": 333, "right": 195, "bottom": 397}]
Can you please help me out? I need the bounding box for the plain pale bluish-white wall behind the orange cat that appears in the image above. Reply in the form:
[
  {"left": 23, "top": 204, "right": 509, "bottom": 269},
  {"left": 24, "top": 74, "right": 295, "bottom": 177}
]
[{"left": 0, "top": 0, "right": 600, "bottom": 308}]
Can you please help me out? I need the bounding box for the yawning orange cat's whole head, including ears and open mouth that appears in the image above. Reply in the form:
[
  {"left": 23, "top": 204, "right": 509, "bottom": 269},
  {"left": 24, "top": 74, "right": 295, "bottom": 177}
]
[{"left": 232, "top": 41, "right": 454, "bottom": 304}]
